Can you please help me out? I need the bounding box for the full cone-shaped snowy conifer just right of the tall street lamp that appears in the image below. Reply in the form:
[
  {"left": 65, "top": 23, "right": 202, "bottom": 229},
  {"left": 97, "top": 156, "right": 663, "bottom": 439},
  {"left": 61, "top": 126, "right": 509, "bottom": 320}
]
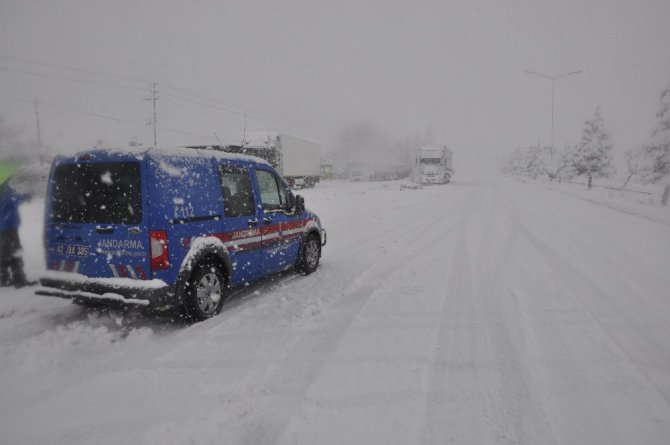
[{"left": 572, "top": 107, "right": 614, "bottom": 189}]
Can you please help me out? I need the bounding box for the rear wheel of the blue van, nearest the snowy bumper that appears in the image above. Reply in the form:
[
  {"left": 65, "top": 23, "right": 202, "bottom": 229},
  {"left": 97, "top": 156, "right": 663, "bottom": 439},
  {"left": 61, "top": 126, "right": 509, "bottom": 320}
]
[{"left": 184, "top": 262, "right": 225, "bottom": 321}]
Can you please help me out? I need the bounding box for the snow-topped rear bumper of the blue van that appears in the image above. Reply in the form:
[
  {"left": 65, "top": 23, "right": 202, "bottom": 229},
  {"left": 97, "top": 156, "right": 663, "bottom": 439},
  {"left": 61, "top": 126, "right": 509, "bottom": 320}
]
[{"left": 35, "top": 272, "right": 179, "bottom": 309}]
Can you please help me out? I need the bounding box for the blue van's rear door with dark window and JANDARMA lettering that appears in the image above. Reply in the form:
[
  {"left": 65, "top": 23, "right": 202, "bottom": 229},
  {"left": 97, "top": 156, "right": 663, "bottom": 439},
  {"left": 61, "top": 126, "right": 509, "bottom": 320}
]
[{"left": 46, "top": 159, "right": 150, "bottom": 279}]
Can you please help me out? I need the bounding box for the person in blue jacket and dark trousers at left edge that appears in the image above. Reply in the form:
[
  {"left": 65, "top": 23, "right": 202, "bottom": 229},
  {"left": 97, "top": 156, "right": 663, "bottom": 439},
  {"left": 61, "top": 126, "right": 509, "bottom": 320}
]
[{"left": 0, "top": 181, "right": 34, "bottom": 288}]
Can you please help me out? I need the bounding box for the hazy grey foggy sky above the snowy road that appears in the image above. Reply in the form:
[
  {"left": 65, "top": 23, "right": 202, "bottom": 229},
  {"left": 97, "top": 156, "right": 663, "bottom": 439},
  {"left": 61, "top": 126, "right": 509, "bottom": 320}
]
[{"left": 0, "top": 0, "right": 670, "bottom": 165}]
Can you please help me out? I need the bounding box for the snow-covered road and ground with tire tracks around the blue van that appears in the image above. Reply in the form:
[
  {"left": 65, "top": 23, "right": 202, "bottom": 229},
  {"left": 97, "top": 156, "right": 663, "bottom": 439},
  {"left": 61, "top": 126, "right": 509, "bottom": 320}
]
[{"left": 0, "top": 178, "right": 670, "bottom": 444}]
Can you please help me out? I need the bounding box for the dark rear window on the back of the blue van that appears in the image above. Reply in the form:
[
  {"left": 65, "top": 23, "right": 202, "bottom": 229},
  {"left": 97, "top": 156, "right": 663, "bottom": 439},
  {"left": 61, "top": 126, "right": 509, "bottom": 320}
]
[{"left": 51, "top": 162, "right": 142, "bottom": 224}]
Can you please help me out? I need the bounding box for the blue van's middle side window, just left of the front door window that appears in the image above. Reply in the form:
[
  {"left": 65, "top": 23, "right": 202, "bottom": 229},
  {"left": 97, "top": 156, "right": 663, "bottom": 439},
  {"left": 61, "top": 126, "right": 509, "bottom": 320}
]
[{"left": 219, "top": 165, "right": 255, "bottom": 216}]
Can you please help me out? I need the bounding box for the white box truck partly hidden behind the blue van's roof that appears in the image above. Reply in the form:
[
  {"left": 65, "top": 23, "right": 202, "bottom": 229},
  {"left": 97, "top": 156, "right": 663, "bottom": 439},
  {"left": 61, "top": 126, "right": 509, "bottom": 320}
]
[{"left": 240, "top": 131, "right": 321, "bottom": 187}]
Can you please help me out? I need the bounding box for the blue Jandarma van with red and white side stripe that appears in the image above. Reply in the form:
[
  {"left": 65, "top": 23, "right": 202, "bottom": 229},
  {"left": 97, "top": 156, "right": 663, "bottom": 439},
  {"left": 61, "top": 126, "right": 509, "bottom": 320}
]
[{"left": 36, "top": 148, "right": 326, "bottom": 320}]
